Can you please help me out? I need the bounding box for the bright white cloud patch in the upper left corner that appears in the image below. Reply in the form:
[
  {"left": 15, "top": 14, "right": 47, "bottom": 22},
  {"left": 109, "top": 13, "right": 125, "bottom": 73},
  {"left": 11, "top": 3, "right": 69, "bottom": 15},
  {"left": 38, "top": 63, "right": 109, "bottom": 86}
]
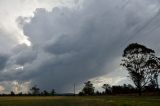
[{"left": 0, "top": 0, "right": 74, "bottom": 48}]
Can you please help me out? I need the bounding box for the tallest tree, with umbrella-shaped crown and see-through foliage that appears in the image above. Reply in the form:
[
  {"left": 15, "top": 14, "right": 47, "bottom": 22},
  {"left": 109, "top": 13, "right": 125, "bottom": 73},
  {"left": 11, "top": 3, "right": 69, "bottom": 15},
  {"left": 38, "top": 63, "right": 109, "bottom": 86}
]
[{"left": 121, "top": 43, "right": 155, "bottom": 95}]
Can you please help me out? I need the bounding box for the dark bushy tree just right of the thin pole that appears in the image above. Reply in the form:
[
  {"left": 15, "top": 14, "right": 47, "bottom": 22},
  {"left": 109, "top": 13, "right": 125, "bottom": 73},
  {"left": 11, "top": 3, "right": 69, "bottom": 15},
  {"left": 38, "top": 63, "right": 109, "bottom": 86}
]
[{"left": 82, "top": 81, "right": 94, "bottom": 95}]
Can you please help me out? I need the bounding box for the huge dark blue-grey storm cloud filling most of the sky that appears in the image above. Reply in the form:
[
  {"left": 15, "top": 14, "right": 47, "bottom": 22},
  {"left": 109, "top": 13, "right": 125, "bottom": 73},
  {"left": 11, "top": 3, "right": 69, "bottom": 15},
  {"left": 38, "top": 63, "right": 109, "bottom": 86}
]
[{"left": 0, "top": 0, "right": 160, "bottom": 92}]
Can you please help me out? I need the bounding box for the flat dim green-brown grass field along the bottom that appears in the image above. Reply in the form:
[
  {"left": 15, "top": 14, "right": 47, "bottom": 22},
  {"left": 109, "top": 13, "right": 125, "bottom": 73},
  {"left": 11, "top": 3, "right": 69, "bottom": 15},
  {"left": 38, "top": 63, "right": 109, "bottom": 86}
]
[{"left": 0, "top": 96, "right": 160, "bottom": 106}]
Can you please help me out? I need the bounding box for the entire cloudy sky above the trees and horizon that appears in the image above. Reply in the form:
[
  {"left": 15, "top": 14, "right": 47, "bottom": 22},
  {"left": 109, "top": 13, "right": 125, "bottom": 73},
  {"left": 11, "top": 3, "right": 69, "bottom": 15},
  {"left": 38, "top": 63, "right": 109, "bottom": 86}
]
[{"left": 0, "top": 0, "right": 160, "bottom": 93}]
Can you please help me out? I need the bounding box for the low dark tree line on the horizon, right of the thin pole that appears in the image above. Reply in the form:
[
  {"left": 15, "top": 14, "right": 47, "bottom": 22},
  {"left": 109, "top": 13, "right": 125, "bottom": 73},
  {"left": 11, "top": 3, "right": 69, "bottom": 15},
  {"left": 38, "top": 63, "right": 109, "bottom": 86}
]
[{"left": 78, "top": 81, "right": 160, "bottom": 96}]
